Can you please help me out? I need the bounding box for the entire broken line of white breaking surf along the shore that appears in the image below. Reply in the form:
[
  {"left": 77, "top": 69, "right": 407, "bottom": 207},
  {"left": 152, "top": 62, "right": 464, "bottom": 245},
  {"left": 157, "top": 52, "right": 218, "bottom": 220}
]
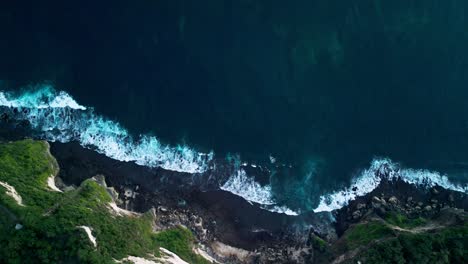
[{"left": 0, "top": 85, "right": 468, "bottom": 215}]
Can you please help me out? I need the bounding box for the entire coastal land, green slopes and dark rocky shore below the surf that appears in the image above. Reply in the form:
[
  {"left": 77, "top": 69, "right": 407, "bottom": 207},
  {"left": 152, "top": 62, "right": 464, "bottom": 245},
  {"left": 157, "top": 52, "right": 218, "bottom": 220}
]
[{"left": 0, "top": 140, "right": 468, "bottom": 263}]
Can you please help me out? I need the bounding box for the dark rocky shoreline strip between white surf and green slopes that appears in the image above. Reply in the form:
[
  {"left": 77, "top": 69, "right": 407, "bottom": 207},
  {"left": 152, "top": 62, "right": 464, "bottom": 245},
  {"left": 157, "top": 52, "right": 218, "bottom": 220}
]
[{"left": 51, "top": 143, "right": 468, "bottom": 263}]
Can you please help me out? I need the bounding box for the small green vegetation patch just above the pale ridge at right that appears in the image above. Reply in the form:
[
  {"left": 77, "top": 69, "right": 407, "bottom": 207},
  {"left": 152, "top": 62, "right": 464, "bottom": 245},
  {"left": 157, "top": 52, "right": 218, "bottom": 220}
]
[{"left": 345, "top": 221, "right": 393, "bottom": 249}]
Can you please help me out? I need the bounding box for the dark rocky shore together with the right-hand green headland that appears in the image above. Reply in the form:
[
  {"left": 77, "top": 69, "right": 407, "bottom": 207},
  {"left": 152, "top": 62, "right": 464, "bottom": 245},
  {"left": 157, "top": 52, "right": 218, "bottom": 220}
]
[{"left": 52, "top": 143, "right": 468, "bottom": 263}]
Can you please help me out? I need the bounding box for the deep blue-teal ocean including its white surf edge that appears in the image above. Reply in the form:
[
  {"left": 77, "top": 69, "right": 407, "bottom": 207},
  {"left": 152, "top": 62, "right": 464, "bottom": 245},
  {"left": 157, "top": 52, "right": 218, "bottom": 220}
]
[{"left": 0, "top": 0, "right": 468, "bottom": 214}]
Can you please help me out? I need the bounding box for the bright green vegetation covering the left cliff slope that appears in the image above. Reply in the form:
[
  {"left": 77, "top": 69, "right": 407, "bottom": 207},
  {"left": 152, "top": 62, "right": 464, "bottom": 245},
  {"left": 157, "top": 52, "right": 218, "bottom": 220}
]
[{"left": 0, "top": 140, "right": 207, "bottom": 263}]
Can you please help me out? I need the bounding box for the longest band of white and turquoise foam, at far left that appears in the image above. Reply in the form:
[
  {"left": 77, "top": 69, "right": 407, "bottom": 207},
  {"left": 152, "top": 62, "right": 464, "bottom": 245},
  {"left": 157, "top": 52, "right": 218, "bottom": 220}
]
[{"left": 0, "top": 85, "right": 213, "bottom": 173}]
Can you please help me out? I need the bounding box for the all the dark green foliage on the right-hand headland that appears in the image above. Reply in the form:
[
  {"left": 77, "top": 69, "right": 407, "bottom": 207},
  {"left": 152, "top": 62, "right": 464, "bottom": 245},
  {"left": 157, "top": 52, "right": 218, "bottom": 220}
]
[{"left": 345, "top": 219, "right": 468, "bottom": 263}]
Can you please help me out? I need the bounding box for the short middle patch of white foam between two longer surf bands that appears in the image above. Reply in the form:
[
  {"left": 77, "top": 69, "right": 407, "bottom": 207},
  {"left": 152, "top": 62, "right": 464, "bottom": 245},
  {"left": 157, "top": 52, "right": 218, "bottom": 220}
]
[{"left": 220, "top": 169, "right": 298, "bottom": 215}]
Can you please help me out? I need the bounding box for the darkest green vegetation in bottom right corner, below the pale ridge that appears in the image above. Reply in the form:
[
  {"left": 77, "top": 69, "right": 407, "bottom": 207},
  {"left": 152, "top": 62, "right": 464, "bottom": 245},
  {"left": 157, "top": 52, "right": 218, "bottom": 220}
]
[{"left": 358, "top": 226, "right": 468, "bottom": 263}]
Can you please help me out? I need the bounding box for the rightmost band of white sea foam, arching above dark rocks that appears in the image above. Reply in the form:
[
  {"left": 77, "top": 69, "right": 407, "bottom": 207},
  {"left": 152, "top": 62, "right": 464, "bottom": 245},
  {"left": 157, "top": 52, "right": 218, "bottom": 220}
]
[{"left": 314, "top": 159, "right": 468, "bottom": 212}]
